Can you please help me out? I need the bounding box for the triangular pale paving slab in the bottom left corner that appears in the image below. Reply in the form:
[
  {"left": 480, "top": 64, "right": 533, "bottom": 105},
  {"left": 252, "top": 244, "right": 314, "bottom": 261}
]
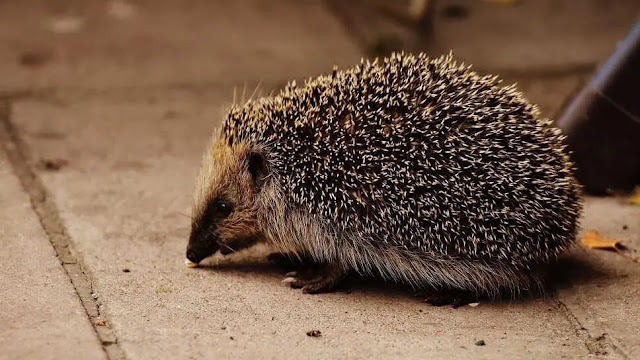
[{"left": 0, "top": 144, "right": 106, "bottom": 359}]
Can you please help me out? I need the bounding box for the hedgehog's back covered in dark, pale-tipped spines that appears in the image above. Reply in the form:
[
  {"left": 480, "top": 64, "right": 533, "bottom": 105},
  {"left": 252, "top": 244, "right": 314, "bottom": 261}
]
[{"left": 222, "top": 54, "right": 580, "bottom": 267}]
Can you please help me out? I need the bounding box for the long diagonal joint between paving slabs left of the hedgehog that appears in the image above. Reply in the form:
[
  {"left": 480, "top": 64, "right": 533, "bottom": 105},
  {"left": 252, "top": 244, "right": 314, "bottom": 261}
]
[{"left": 0, "top": 99, "right": 126, "bottom": 360}]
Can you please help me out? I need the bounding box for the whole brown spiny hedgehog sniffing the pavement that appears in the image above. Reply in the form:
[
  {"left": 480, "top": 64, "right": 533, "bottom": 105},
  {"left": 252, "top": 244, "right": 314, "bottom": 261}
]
[{"left": 185, "top": 53, "right": 581, "bottom": 305}]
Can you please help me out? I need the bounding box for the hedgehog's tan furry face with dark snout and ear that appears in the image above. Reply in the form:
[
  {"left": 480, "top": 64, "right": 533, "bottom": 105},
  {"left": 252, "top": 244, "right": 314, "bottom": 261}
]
[{"left": 187, "top": 141, "right": 267, "bottom": 264}]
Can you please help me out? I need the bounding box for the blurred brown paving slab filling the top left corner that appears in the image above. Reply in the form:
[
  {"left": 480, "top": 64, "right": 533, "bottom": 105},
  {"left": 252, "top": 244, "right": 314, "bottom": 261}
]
[{"left": 0, "top": 0, "right": 360, "bottom": 95}]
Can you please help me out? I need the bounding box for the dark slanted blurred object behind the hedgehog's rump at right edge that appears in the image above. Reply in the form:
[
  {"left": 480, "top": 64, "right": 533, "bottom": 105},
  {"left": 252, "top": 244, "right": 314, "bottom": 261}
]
[{"left": 558, "top": 22, "right": 640, "bottom": 194}]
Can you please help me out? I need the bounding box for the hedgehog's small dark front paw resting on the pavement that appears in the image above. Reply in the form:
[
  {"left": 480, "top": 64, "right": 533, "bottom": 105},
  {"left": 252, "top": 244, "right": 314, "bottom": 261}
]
[{"left": 282, "top": 264, "right": 344, "bottom": 294}]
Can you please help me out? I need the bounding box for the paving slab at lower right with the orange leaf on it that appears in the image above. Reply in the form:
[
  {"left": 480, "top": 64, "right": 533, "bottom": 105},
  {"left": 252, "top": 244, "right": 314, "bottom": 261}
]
[{"left": 559, "top": 197, "right": 640, "bottom": 359}]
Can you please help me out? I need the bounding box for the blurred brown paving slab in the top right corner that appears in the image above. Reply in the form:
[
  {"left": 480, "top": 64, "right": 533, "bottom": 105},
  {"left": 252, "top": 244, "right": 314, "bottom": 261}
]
[{"left": 430, "top": 0, "right": 640, "bottom": 73}]
